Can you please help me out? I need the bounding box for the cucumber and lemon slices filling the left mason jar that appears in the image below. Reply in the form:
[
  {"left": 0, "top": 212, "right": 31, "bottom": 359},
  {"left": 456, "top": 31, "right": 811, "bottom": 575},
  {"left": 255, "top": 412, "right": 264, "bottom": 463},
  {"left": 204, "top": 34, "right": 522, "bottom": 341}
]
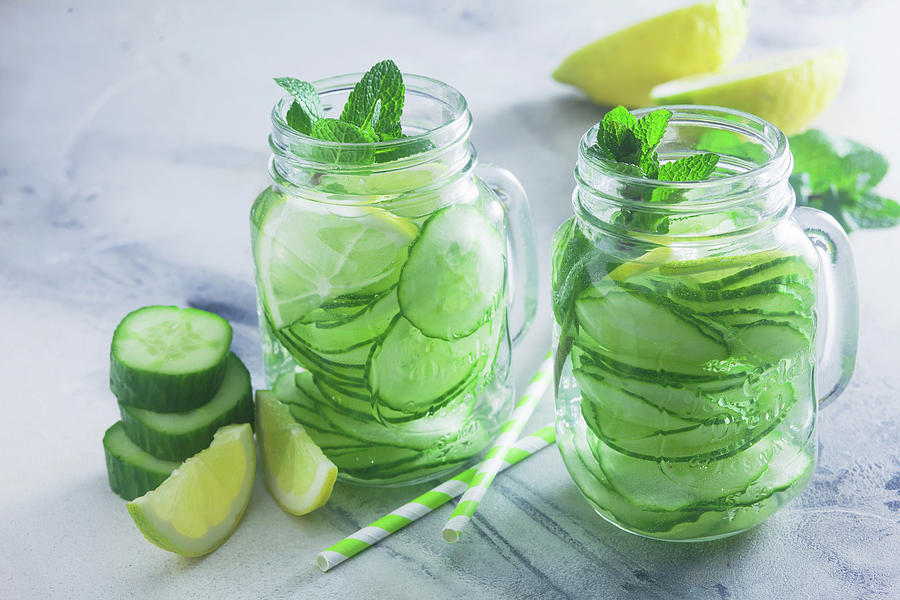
[{"left": 254, "top": 190, "right": 506, "bottom": 482}]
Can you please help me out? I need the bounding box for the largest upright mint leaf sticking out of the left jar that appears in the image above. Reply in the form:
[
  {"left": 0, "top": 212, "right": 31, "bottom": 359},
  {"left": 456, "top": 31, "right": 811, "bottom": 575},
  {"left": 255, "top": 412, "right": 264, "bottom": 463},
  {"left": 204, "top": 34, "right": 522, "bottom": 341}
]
[{"left": 341, "top": 60, "right": 406, "bottom": 137}]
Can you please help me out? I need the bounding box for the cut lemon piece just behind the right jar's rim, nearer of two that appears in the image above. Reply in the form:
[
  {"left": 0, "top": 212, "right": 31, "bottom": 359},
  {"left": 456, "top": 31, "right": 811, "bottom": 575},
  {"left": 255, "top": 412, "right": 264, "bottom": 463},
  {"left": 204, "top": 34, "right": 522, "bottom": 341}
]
[{"left": 650, "top": 47, "right": 847, "bottom": 134}]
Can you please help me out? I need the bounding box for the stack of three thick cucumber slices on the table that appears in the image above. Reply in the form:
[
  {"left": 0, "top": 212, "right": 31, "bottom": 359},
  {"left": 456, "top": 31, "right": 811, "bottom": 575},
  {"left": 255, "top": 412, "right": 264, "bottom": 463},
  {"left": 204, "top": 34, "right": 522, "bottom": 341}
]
[{"left": 103, "top": 306, "right": 253, "bottom": 500}]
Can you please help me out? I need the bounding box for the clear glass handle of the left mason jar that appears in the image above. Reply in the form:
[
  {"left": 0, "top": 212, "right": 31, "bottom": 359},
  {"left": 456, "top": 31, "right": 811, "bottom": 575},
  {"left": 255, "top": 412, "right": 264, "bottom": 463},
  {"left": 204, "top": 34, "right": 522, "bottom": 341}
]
[{"left": 476, "top": 163, "right": 538, "bottom": 344}]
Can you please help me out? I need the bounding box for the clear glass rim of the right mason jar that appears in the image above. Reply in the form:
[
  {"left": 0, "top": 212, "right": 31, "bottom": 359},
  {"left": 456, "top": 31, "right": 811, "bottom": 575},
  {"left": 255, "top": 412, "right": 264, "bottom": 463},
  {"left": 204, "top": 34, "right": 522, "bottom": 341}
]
[{"left": 576, "top": 104, "right": 793, "bottom": 206}]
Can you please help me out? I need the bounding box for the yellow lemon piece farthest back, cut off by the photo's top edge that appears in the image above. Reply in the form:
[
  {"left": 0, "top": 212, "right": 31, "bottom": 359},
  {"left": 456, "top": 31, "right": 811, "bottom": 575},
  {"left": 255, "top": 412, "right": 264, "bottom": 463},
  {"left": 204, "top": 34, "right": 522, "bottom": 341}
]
[{"left": 553, "top": 0, "right": 747, "bottom": 107}]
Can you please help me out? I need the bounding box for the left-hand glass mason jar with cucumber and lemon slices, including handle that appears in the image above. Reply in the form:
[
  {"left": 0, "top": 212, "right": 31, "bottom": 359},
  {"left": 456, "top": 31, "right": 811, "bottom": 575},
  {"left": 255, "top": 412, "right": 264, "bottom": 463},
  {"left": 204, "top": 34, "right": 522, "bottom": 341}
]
[{"left": 251, "top": 74, "right": 537, "bottom": 485}]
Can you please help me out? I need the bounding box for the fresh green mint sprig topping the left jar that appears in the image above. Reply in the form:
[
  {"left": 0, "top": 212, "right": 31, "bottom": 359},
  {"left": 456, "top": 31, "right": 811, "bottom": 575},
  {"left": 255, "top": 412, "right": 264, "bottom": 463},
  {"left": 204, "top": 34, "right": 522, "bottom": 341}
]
[{"left": 275, "top": 60, "right": 432, "bottom": 165}]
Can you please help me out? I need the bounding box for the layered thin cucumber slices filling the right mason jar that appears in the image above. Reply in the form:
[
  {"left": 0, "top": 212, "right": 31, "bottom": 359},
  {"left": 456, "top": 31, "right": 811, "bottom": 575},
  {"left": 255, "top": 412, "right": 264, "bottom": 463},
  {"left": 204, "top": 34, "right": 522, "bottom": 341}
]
[{"left": 554, "top": 231, "right": 816, "bottom": 539}]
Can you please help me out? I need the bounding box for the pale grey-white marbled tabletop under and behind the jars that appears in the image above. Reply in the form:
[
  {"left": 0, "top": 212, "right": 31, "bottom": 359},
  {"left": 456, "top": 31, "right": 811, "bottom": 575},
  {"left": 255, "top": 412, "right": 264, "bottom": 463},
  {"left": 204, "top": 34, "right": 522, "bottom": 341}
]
[{"left": 0, "top": 0, "right": 900, "bottom": 599}]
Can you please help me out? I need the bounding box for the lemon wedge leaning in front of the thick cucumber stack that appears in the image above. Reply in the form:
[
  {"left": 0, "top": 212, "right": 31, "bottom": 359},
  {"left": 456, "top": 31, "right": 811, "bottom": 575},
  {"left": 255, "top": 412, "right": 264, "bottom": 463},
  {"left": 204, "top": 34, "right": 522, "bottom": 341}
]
[{"left": 128, "top": 423, "right": 256, "bottom": 556}]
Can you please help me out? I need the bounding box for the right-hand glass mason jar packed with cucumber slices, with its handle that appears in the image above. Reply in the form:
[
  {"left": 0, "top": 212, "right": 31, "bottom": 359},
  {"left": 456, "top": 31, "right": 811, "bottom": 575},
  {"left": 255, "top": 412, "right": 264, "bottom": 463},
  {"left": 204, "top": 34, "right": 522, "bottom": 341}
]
[{"left": 552, "top": 106, "right": 858, "bottom": 541}]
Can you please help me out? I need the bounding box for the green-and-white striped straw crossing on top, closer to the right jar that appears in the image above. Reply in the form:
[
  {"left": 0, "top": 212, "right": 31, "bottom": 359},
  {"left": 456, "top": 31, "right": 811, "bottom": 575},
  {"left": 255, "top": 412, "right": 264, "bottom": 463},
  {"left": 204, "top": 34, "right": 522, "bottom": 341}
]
[{"left": 441, "top": 352, "right": 553, "bottom": 543}]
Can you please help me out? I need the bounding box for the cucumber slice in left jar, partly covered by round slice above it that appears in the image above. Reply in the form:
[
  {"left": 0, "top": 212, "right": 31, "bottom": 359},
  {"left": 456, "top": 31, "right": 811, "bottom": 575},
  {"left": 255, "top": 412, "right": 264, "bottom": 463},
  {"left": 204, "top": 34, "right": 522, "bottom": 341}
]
[{"left": 366, "top": 317, "right": 501, "bottom": 414}]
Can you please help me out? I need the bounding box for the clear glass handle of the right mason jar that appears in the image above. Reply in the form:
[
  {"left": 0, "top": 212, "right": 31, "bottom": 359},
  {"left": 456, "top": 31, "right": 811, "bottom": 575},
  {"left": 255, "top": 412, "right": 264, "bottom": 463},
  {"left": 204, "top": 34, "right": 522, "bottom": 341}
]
[{"left": 793, "top": 206, "right": 859, "bottom": 407}]
